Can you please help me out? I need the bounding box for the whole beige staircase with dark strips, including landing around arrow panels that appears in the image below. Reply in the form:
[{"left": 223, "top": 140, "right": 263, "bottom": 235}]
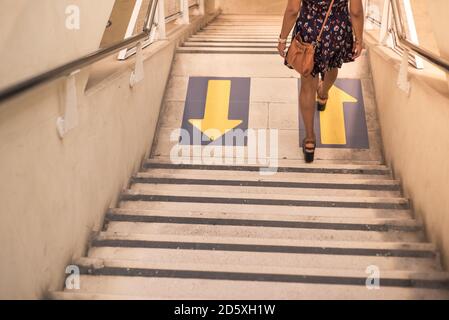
[{"left": 52, "top": 16, "right": 449, "bottom": 300}]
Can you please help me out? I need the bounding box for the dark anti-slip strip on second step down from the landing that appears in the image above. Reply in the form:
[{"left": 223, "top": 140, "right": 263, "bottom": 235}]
[{"left": 132, "top": 177, "right": 400, "bottom": 191}]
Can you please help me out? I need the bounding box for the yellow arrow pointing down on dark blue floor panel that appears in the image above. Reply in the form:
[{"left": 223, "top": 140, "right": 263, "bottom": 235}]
[{"left": 189, "top": 80, "right": 243, "bottom": 141}]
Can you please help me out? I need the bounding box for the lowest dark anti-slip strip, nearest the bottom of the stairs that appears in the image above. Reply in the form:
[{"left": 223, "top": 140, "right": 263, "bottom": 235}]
[{"left": 80, "top": 267, "right": 449, "bottom": 289}]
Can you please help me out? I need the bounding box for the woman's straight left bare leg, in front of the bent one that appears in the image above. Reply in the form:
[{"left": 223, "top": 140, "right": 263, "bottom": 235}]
[{"left": 299, "top": 76, "right": 318, "bottom": 144}]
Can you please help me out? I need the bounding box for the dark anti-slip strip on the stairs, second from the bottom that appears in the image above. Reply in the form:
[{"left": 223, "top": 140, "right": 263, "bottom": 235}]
[{"left": 92, "top": 239, "right": 435, "bottom": 258}]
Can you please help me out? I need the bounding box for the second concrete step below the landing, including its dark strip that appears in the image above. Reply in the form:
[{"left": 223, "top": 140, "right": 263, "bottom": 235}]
[{"left": 131, "top": 175, "right": 401, "bottom": 197}]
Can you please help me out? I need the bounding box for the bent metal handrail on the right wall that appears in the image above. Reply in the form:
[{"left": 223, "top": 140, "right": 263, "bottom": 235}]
[{"left": 390, "top": 0, "right": 449, "bottom": 73}]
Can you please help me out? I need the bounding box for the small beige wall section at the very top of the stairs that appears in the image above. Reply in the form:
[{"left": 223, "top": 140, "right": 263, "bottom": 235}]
[{"left": 219, "top": 0, "right": 288, "bottom": 15}]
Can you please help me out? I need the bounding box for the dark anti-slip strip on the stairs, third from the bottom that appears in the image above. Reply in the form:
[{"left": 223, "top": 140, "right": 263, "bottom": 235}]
[{"left": 107, "top": 213, "right": 421, "bottom": 232}]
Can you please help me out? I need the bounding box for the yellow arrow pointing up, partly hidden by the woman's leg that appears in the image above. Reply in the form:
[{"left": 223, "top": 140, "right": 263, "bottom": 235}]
[{"left": 320, "top": 86, "right": 357, "bottom": 145}]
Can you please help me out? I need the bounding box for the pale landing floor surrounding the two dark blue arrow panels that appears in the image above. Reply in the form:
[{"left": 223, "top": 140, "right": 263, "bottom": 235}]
[{"left": 153, "top": 42, "right": 383, "bottom": 163}]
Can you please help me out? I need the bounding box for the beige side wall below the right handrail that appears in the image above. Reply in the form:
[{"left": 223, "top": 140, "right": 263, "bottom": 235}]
[{"left": 368, "top": 41, "right": 449, "bottom": 268}]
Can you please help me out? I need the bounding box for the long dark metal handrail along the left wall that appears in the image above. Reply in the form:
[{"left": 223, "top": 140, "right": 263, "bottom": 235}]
[{"left": 0, "top": 0, "right": 159, "bottom": 103}]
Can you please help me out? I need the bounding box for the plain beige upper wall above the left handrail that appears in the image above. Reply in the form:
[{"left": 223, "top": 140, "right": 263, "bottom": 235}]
[{"left": 0, "top": 0, "right": 114, "bottom": 88}]
